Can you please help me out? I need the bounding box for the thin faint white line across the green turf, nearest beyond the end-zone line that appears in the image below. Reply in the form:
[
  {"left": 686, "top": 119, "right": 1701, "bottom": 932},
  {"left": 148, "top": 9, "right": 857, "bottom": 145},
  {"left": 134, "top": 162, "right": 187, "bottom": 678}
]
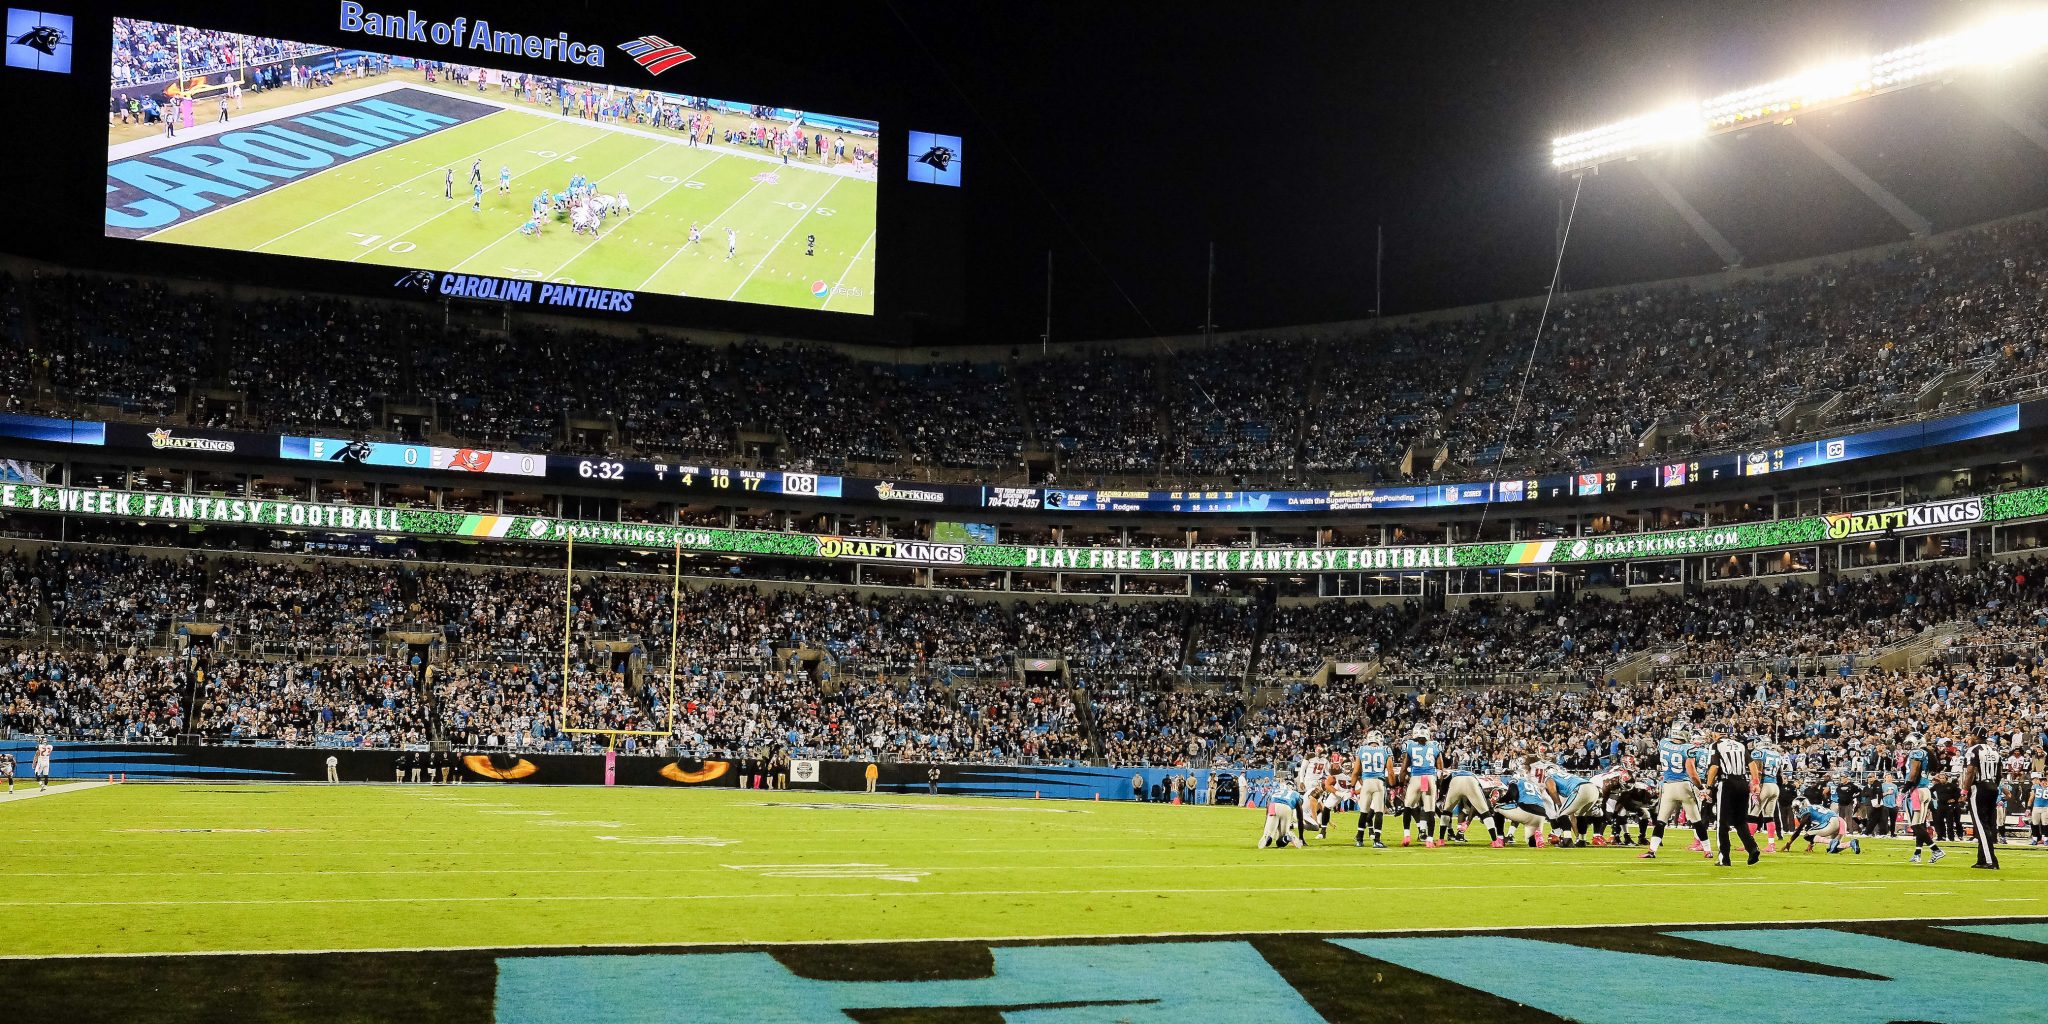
[{"left": 0, "top": 879, "right": 2031, "bottom": 907}]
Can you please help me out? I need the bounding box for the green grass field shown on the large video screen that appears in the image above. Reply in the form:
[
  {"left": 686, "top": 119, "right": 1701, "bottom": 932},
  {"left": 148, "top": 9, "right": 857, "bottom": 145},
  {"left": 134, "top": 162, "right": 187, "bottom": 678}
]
[{"left": 147, "top": 96, "right": 877, "bottom": 313}]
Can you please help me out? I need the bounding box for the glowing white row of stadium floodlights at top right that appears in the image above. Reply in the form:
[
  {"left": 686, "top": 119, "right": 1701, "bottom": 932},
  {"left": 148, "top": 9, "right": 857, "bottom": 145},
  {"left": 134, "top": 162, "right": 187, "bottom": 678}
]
[{"left": 1550, "top": 8, "right": 2048, "bottom": 174}]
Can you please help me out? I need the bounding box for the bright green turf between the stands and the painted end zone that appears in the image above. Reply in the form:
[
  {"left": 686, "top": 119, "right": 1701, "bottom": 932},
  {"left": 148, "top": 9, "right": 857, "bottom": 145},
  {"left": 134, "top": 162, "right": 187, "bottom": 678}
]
[{"left": 0, "top": 784, "right": 2048, "bottom": 954}]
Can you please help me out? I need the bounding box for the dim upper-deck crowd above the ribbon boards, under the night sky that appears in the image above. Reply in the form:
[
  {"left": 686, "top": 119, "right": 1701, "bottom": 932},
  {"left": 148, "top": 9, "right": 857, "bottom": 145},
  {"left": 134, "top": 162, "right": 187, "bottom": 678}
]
[{"left": 12, "top": 208, "right": 2048, "bottom": 485}]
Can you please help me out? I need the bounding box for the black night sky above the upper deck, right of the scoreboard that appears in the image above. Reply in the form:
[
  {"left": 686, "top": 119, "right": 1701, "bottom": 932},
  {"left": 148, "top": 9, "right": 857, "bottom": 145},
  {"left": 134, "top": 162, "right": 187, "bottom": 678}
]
[{"left": 883, "top": 0, "right": 2048, "bottom": 342}]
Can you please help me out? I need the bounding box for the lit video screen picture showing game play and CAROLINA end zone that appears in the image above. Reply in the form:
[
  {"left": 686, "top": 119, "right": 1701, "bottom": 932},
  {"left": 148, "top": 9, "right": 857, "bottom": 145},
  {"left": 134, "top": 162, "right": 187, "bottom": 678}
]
[{"left": 106, "top": 18, "right": 881, "bottom": 313}]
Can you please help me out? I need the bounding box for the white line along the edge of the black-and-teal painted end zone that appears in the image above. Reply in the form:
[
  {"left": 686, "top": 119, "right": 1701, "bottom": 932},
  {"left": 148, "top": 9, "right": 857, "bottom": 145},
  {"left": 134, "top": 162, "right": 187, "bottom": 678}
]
[{"left": 0, "top": 913, "right": 2048, "bottom": 961}]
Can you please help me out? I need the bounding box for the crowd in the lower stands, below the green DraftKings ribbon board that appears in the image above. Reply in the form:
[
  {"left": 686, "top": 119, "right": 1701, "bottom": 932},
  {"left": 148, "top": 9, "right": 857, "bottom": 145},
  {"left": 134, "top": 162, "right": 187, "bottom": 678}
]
[{"left": 0, "top": 545, "right": 2048, "bottom": 766}]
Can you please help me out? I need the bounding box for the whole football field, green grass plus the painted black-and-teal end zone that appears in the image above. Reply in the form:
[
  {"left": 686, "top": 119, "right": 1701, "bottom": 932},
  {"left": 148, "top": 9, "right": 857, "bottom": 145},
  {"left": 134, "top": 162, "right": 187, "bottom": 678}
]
[{"left": 12, "top": 784, "right": 2048, "bottom": 1024}]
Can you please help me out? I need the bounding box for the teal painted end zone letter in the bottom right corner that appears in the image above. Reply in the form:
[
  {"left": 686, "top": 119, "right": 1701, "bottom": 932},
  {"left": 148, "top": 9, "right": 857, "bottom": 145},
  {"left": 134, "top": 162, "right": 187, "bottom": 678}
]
[{"left": 1331, "top": 928, "right": 2048, "bottom": 1024}]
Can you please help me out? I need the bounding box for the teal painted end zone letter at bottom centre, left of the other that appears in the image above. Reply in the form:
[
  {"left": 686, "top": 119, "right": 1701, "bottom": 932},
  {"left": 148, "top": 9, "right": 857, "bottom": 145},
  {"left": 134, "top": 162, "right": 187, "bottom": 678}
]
[{"left": 498, "top": 942, "right": 1323, "bottom": 1024}]
